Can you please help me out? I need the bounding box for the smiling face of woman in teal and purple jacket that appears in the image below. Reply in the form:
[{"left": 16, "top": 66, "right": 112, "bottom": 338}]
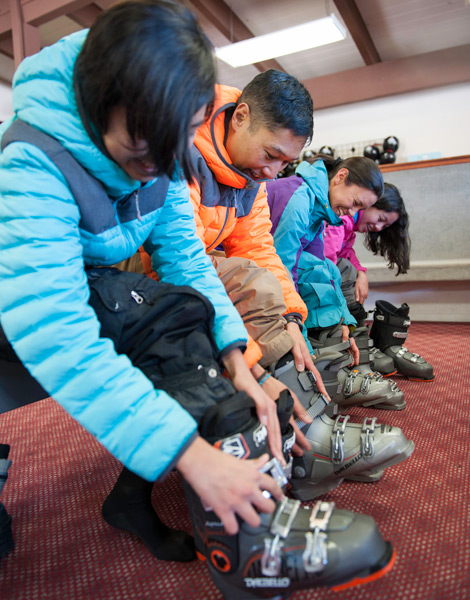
[{"left": 328, "top": 169, "right": 377, "bottom": 217}]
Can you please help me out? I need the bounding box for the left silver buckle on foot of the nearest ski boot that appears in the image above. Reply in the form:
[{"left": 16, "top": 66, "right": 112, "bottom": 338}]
[{"left": 261, "top": 496, "right": 300, "bottom": 577}]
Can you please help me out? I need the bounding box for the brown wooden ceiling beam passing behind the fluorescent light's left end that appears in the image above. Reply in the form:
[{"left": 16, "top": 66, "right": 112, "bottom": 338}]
[{"left": 188, "top": 0, "right": 284, "bottom": 72}]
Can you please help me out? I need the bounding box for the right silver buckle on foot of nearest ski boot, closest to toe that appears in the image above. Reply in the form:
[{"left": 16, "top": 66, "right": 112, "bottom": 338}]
[{"left": 302, "top": 501, "right": 335, "bottom": 573}]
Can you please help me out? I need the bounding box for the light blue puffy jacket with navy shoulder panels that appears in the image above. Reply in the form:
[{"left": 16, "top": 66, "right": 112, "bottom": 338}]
[{"left": 0, "top": 31, "right": 247, "bottom": 480}]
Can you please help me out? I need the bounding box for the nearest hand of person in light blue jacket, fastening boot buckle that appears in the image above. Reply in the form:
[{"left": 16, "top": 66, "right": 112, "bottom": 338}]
[{"left": 176, "top": 437, "right": 283, "bottom": 535}]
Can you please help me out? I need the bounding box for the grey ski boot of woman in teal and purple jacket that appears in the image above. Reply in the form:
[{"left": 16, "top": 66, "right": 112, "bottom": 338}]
[{"left": 309, "top": 323, "right": 406, "bottom": 410}]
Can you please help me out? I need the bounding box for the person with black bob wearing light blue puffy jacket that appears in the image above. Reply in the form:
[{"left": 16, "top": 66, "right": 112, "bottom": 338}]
[{"left": 0, "top": 0, "right": 283, "bottom": 561}]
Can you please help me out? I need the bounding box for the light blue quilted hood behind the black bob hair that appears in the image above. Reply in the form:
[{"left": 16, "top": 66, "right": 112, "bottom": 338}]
[{"left": 8, "top": 30, "right": 140, "bottom": 196}]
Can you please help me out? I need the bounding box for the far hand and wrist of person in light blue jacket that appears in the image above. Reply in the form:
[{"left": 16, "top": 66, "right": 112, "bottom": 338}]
[{"left": 222, "top": 348, "right": 285, "bottom": 465}]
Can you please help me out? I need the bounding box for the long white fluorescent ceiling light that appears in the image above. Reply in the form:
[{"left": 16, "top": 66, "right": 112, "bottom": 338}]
[{"left": 215, "top": 14, "right": 346, "bottom": 67}]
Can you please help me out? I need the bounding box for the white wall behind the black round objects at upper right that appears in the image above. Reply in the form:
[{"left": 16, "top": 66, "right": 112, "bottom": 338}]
[{"left": 311, "top": 83, "right": 470, "bottom": 162}]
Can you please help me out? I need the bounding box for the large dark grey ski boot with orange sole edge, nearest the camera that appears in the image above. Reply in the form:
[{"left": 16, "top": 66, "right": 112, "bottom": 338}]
[{"left": 184, "top": 394, "right": 395, "bottom": 600}]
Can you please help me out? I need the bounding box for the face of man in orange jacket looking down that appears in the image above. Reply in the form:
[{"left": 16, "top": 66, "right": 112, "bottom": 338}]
[{"left": 226, "top": 103, "right": 306, "bottom": 181}]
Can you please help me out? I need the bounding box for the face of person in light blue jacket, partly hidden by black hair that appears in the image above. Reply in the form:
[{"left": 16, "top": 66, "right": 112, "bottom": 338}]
[{"left": 103, "top": 105, "right": 206, "bottom": 183}]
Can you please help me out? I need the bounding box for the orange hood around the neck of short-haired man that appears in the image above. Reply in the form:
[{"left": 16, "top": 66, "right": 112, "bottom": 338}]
[{"left": 194, "top": 85, "right": 259, "bottom": 189}]
